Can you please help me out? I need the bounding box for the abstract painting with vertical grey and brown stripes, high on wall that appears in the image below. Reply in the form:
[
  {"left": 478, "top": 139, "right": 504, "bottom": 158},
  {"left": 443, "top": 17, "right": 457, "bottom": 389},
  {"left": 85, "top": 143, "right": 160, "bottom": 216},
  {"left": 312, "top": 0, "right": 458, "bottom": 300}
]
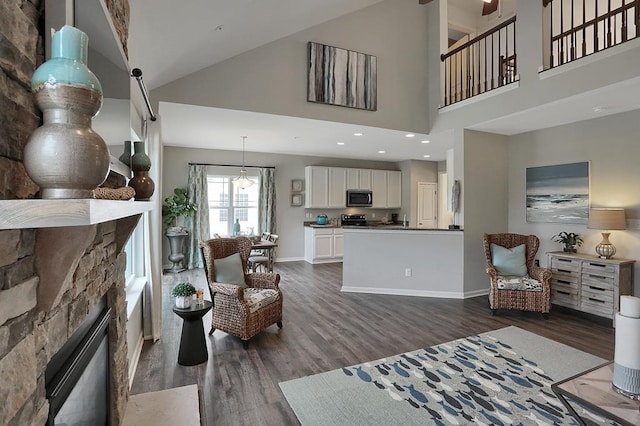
[{"left": 307, "top": 42, "right": 378, "bottom": 111}]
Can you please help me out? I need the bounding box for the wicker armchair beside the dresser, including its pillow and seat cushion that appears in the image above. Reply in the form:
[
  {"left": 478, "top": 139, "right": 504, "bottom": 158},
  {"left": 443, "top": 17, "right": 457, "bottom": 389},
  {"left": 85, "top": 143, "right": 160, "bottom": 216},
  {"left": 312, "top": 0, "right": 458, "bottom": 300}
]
[{"left": 483, "top": 234, "right": 551, "bottom": 318}]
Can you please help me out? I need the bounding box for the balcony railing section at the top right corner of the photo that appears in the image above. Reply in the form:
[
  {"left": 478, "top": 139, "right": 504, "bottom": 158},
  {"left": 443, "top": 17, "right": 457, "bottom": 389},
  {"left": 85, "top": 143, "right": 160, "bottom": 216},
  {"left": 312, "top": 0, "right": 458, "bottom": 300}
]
[{"left": 545, "top": 0, "right": 640, "bottom": 68}]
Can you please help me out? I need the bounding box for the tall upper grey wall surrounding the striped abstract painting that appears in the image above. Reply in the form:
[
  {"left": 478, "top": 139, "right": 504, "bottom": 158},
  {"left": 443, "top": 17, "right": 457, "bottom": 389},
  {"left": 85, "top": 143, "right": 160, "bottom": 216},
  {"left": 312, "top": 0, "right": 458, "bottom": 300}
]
[{"left": 151, "top": 0, "right": 429, "bottom": 133}]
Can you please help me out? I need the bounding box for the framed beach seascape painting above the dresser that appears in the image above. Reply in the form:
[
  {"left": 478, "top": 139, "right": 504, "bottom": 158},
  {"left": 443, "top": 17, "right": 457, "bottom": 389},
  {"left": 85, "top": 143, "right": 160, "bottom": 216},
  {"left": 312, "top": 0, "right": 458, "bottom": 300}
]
[{"left": 527, "top": 161, "right": 589, "bottom": 224}]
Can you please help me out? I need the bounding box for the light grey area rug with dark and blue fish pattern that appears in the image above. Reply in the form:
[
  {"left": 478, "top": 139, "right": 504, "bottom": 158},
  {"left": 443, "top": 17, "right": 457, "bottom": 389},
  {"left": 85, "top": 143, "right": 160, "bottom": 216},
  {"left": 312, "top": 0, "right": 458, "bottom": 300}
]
[{"left": 280, "top": 326, "right": 607, "bottom": 426}]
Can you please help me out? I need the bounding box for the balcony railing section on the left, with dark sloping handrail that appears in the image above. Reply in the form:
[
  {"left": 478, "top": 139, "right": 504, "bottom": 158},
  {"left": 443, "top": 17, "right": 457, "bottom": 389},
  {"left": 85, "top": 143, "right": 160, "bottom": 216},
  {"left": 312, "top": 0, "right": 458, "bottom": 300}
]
[{"left": 440, "top": 16, "right": 518, "bottom": 106}]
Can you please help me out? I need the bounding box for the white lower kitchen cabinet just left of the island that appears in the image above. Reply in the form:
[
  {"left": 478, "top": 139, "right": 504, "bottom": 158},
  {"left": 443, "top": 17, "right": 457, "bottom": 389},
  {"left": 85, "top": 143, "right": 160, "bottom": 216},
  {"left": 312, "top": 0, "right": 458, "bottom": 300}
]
[{"left": 304, "top": 226, "right": 344, "bottom": 264}]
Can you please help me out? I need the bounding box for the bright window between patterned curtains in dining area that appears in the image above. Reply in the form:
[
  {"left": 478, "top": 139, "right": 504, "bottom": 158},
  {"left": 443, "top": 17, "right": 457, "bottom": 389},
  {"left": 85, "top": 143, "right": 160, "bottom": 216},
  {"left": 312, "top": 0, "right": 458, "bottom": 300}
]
[{"left": 207, "top": 171, "right": 260, "bottom": 235}]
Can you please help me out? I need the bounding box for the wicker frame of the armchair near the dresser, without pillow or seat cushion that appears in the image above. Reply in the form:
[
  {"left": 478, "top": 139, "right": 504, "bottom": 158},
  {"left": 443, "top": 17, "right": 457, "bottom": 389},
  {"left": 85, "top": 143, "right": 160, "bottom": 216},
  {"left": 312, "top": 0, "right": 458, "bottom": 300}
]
[{"left": 483, "top": 234, "right": 551, "bottom": 318}]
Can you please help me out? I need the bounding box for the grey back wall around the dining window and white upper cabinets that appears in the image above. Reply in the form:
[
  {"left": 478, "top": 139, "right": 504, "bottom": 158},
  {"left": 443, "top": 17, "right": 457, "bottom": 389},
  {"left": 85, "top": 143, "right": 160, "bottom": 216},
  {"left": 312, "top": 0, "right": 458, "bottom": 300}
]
[{"left": 162, "top": 147, "right": 437, "bottom": 262}]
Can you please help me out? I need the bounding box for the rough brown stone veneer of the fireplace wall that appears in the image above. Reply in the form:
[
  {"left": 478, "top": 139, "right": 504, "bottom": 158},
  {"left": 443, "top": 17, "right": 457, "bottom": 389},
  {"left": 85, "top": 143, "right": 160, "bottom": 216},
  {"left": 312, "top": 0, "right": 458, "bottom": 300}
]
[{"left": 0, "top": 0, "right": 129, "bottom": 426}]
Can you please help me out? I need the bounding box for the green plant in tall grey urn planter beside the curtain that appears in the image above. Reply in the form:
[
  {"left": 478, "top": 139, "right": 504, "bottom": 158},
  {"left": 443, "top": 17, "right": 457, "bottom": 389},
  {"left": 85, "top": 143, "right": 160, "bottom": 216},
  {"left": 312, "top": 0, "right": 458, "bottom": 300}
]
[{"left": 162, "top": 188, "right": 197, "bottom": 272}]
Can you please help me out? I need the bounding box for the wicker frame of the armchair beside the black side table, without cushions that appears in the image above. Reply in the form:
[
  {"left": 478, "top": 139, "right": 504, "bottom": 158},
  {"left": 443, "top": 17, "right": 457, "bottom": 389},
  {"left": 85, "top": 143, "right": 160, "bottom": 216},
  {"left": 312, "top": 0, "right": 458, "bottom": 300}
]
[{"left": 200, "top": 237, "right": 283, "bottom": 348}]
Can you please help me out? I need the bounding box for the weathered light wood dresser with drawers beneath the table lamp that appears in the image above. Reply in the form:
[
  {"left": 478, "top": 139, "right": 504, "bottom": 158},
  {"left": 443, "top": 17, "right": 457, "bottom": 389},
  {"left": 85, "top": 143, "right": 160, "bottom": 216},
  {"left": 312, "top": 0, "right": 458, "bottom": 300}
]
[{"left": 548, "top": 252, "right": 635, "bottom": 319}]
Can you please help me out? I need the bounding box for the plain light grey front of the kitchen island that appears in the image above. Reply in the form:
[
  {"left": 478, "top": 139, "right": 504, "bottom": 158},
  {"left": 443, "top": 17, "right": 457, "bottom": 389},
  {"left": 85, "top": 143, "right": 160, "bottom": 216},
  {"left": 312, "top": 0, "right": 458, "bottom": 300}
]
[{"left": 342, "top": 225, "right": 462, "bottom": 299}]
